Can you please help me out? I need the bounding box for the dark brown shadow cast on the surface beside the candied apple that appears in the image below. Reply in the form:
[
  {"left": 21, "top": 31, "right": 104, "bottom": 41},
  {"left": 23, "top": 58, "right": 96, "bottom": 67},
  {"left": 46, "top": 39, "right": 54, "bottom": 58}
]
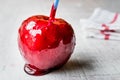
[{"left": 52, "top": 53, "right": 95, "bottom": 74}]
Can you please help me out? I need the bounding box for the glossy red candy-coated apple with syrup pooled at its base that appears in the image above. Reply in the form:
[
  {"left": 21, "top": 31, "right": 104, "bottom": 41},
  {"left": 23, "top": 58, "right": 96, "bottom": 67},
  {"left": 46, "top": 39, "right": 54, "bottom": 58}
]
[{"left": 18, "top": 15, "right": 75, "bottom": 75}]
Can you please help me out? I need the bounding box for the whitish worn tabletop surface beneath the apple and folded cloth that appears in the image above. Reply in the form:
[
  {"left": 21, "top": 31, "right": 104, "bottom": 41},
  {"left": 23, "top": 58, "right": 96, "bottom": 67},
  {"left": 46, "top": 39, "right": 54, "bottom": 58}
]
[{"left": 0, "top": 0, "right": 120, "bottom": 80}]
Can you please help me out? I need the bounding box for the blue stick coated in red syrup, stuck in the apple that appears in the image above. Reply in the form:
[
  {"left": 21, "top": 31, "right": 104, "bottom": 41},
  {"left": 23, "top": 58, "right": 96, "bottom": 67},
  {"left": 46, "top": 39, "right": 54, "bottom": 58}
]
[{"left": 49, "top": 0, "right": 59, "bottom": 22}]
